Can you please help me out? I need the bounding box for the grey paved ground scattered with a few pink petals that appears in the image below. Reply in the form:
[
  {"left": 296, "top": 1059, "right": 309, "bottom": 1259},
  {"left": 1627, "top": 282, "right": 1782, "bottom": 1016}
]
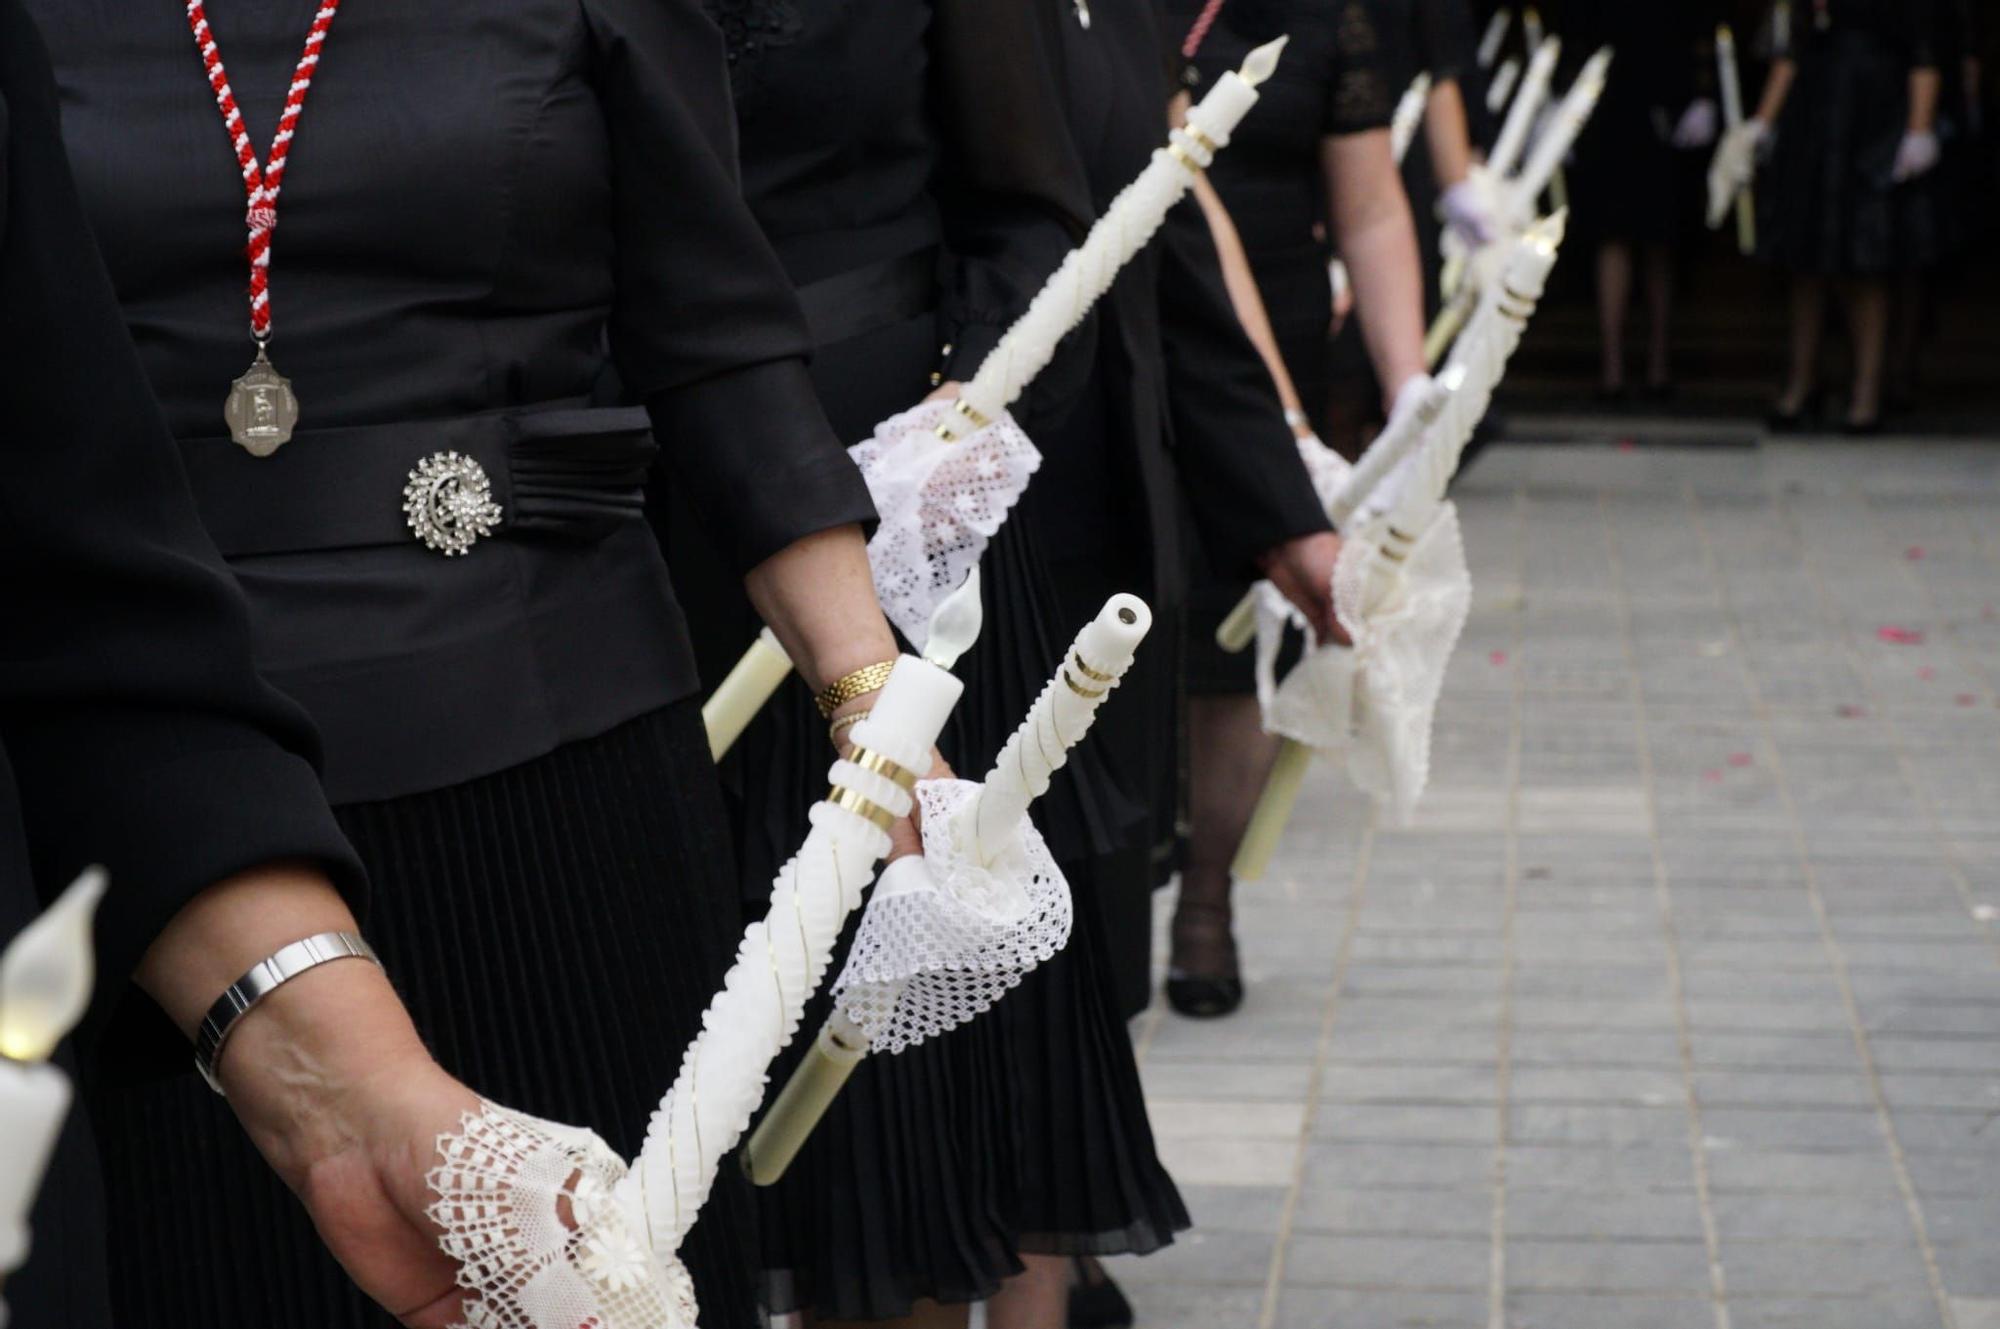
[{"left": 1112, "top": 444, "right": 2000, "bottom": 1329}]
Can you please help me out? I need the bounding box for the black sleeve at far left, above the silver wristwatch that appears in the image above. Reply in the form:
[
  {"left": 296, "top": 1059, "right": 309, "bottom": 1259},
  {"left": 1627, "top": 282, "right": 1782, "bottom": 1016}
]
[{"left": 0, "top": 0, "right": 362, "bottom": 1055}]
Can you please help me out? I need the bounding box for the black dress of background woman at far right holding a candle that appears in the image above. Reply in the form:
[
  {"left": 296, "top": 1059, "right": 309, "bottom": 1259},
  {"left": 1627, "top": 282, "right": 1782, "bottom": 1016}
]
[{"left": 1758, "top": 0, "right": 1942, "bottom": 276}]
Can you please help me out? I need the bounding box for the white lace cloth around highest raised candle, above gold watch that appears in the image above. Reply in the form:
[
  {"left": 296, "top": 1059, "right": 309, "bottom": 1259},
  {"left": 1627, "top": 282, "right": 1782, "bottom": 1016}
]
[{"left": 848, "top": 402, "right": 1042, "bottom": 650}]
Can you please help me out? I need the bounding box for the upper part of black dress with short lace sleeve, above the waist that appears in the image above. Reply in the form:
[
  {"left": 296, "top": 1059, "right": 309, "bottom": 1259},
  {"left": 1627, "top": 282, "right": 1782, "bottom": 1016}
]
[{"left": 1164, "top": 0, "right": 1402, "bottom": 254}]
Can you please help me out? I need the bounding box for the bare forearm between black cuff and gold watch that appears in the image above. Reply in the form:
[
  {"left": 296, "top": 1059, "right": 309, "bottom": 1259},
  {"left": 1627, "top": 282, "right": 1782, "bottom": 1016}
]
[{"left": 744, "top": 526, "right": 896, "bottom": 691}]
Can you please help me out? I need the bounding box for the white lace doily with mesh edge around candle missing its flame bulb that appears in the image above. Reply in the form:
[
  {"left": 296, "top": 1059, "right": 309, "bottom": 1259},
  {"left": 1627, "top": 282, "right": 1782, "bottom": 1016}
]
[{"left": 834, "top": 781, "right": 1076, "bottom": 1053}]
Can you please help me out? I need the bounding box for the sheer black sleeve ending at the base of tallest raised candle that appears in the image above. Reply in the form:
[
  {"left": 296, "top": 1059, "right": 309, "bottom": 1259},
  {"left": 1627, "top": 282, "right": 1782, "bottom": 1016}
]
[{"left": 930, "top": 0, "right": 1092, "bottom": 390}]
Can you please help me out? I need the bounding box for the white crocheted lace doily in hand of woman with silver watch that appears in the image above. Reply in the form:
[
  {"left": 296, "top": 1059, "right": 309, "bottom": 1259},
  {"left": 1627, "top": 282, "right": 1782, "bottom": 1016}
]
[{"left": 430, "top": 1103, "right": 696, "bottom": 1329}]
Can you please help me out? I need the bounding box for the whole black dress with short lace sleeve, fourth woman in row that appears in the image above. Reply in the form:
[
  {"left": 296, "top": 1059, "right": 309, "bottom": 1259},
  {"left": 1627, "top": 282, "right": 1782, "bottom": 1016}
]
[{"left": 1162, "top": 0, "right": 1400, "bottom": 695}]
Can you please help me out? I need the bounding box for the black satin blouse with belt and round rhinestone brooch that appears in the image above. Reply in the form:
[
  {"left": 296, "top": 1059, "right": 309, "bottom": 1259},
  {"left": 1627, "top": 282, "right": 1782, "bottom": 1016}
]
[{"left": 30, "top": 0, "right": 870, "bottom": 801}]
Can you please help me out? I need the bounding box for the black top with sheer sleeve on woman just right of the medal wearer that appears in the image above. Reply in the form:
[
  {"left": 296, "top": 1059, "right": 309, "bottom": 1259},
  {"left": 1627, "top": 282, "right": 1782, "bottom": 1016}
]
[{"left": 706, "top": 0, "right": 1092, "bottom": 390}]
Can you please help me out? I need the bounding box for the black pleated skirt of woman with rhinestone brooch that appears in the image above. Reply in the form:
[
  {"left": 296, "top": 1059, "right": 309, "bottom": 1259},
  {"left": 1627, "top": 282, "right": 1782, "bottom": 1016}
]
[{"left": 90, "top": 701, "right": 760, "bottom": 1329}]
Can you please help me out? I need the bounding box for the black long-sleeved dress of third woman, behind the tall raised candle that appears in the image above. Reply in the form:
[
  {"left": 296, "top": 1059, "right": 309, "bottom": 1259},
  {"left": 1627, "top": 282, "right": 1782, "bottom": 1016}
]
[{"left": 1022, "top": 0, "right": 1326, "bottom": 1015}]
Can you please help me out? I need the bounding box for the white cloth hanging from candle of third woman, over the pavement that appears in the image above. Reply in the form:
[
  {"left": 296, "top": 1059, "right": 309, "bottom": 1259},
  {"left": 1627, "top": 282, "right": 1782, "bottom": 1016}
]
[{"left": 1256, "top": 502, "right": 1472, "bottom": 823}]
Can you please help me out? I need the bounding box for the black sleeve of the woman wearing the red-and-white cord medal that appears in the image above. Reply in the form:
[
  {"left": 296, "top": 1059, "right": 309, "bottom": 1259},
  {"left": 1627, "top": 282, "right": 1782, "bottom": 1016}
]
[{"left": 584, "top": 0, "right": 874, "bottom": 570}]
